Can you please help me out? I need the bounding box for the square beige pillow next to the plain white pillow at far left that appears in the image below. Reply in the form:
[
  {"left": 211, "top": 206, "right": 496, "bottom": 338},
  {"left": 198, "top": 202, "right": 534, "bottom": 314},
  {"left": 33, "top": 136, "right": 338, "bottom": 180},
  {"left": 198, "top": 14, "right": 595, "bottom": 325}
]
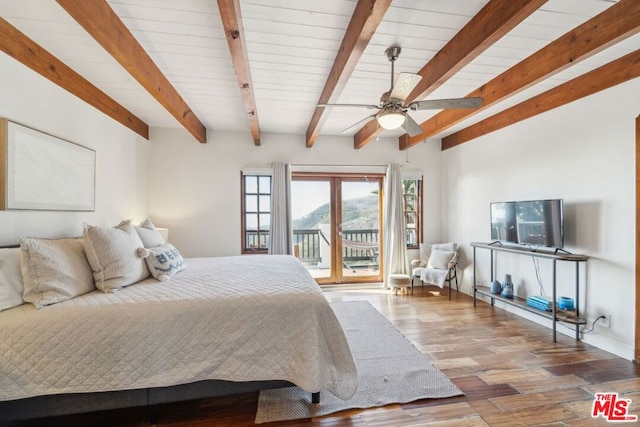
[{"left": 20, "top": 238, "right": 95, "bottom": 308}]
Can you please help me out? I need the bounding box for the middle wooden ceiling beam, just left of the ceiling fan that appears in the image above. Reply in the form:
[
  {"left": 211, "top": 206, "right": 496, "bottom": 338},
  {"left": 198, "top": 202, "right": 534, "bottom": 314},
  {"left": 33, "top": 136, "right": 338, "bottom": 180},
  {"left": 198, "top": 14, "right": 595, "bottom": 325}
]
[{"left": 306, "top": 0, "right": 391, "bottom": 148}]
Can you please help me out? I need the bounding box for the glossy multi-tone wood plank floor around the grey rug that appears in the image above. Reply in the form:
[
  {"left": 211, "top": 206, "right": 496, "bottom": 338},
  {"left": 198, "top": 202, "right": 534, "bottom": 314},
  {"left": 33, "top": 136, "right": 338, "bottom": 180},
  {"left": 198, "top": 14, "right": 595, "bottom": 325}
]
[{"left": 10, "top": 286, "right": 640, "bottom": 427}]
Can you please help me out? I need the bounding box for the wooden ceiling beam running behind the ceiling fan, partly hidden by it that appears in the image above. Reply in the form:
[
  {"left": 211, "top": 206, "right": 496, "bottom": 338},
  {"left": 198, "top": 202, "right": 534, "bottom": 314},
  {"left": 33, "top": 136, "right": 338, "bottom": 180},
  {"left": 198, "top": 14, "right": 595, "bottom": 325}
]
[{"left": 353, "top": 0, "right": 547, "bottom": 149}]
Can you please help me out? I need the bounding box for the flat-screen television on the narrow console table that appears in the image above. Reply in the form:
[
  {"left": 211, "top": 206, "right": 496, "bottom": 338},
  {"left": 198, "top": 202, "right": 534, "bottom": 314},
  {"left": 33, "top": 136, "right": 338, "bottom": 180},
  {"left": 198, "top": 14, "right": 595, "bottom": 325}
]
[{"left": 491, "top": 199, "right": 564, "bottom": 248}]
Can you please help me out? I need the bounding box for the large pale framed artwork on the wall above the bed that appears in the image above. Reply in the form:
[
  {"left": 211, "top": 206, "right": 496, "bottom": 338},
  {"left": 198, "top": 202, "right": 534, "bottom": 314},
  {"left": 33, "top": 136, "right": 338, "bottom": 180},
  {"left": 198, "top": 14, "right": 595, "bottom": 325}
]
[{"left": 0, "top": 119, "right": 96, "bottom": 211}]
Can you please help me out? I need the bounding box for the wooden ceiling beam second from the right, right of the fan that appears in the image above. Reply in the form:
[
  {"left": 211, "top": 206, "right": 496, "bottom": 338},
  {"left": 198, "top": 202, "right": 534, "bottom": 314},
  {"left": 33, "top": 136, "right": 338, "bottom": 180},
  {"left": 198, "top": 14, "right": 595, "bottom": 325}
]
[{"left": 399, "top": 0, "right": 640, "bottom": 150}]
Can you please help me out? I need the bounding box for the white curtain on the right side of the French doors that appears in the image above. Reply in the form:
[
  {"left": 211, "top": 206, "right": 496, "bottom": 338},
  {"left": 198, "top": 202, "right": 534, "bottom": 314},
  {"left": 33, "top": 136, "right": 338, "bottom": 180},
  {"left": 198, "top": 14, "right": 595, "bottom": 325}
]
[{"left": 383, "top": 164, "right": 409, "bottom": 285}]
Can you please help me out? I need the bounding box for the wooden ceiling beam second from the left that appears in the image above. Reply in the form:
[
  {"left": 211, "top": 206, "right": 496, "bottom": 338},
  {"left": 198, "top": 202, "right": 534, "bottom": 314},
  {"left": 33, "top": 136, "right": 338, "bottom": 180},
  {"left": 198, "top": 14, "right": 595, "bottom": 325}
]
[{"left": 56, "top": 0, "right": 207, "bottom": 144}]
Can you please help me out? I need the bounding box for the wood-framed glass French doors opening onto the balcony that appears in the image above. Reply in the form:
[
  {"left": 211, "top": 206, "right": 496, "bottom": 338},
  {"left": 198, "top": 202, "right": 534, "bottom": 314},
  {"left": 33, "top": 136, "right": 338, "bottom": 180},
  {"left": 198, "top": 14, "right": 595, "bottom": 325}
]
[{"left": 291, "top": 173, "right": 383, "bottom": 284}]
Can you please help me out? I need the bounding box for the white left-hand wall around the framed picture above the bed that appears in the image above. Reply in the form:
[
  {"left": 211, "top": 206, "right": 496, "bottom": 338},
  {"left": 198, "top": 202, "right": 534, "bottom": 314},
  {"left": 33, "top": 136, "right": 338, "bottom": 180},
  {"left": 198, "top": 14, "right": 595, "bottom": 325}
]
[{"left": 0, "top": 53, "right": 150, "bottom": 245}]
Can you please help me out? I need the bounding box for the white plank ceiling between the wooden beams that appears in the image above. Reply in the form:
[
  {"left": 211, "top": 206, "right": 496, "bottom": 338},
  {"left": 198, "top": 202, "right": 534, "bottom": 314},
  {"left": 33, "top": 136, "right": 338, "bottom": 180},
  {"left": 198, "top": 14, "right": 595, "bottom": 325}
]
[{"left": 0, "top": 0, "right": 640, "bottom": 145}]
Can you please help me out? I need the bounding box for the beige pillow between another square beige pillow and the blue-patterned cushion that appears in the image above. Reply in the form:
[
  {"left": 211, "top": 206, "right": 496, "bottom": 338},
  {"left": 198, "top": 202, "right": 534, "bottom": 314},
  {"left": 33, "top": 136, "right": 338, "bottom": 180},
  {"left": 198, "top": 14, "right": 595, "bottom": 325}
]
[{"left": 84, "top": 220, "right": 149, "bottom": 292}]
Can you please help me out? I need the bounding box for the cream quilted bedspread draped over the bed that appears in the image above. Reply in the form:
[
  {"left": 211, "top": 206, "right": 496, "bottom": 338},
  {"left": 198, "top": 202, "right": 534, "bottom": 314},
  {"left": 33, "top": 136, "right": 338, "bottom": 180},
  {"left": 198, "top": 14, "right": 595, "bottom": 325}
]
[{"left": 0, "top": 255, "right": 357, "bottom": 401}]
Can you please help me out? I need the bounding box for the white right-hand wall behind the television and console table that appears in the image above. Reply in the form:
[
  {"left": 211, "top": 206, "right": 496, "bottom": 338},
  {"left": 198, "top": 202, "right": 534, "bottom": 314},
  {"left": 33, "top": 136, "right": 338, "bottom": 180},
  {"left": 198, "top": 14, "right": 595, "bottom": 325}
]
[{"left": 442, "top": 79, "right": 640, "bottom": 359}]
